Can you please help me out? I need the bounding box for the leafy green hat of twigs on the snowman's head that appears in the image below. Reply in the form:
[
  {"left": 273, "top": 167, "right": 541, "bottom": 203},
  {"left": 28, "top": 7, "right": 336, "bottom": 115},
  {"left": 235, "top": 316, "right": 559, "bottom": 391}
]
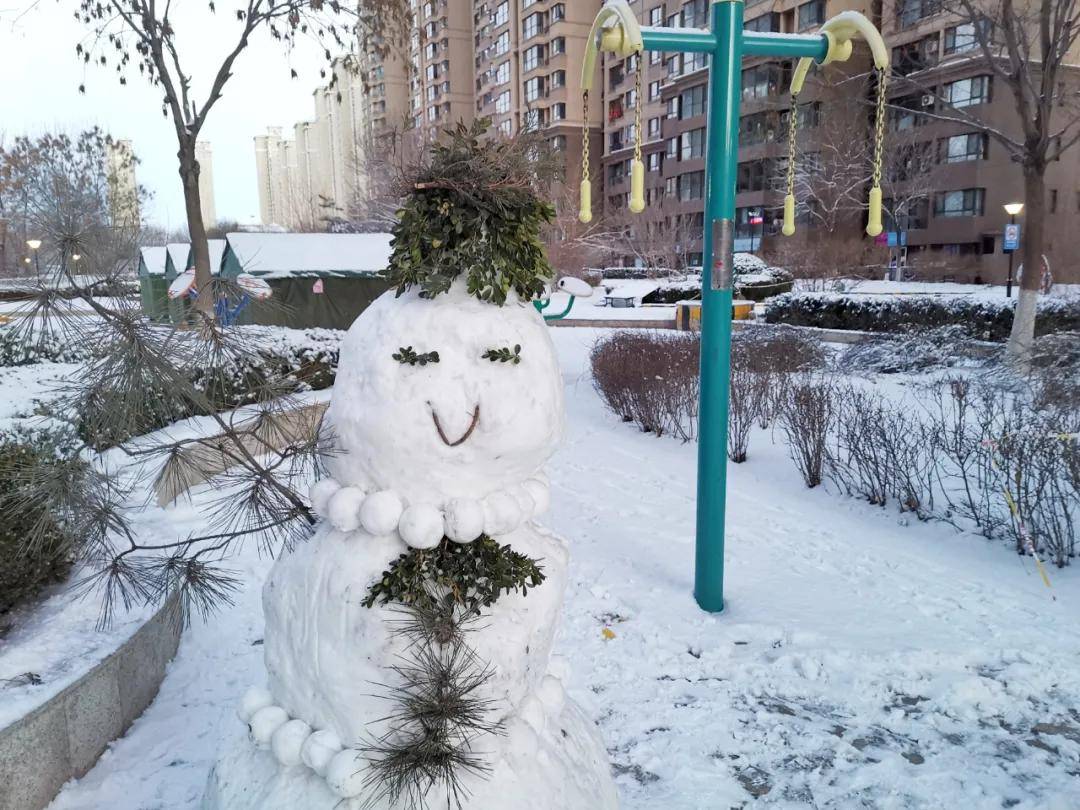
[{"left": 387, "top": 120, "right": 555, "bottom": 306}]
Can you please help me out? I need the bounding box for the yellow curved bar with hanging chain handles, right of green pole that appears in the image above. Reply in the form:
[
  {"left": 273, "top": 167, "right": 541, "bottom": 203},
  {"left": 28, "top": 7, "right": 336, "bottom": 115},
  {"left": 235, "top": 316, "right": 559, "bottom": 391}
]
[{"left": 782, "top": 11, "right": 889, "bottom": 237}]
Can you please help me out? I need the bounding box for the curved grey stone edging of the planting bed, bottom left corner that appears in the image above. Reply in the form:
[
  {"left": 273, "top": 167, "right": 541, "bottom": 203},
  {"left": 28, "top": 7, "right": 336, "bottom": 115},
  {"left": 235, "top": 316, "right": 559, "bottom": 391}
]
[{"left": 0, "top": 602, "right": 181, "bottom": 810}]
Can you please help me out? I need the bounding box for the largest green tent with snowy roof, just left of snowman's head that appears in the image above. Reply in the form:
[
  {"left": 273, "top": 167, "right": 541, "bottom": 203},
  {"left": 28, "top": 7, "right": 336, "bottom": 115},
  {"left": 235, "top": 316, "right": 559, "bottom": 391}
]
[{"left": 221, "top": 233, "right": 391, "bottom": 329}]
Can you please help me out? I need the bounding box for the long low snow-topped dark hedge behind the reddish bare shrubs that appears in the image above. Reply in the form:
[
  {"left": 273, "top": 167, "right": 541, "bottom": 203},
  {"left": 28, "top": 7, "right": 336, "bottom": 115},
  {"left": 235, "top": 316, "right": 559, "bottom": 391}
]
[{"left": 765, "top": 293, "right": 1080, "bottom": 341}]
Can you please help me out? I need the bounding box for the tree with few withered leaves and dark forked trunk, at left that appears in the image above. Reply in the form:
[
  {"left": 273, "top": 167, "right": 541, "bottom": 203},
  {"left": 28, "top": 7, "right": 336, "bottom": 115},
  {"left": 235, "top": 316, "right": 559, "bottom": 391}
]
[{"left": 72, "top": 0, "right": 409, "bottom": 319}]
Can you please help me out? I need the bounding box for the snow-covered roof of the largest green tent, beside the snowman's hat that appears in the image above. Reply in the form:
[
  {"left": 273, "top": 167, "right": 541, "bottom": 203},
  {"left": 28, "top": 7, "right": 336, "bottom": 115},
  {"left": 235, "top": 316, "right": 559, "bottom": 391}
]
[{"left": 227, "top": 233, "right": 392, "bottom": 278}]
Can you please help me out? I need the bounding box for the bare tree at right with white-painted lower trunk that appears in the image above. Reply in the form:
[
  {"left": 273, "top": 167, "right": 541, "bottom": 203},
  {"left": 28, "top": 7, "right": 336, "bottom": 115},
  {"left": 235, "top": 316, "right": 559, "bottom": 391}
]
[{"left": 906, "top": 0, "right": 1080, "bottom": 368}]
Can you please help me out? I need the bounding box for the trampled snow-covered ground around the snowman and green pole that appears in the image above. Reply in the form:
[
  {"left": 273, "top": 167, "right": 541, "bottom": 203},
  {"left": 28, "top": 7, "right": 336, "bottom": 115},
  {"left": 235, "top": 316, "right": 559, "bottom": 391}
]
[{"left": 52, "top": 329, "right": 1080, "bottom": 810}]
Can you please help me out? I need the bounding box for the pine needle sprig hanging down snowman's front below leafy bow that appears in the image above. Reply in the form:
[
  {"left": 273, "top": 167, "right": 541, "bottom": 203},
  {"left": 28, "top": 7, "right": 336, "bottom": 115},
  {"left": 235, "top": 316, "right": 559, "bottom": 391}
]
[{"left": 363, "top": 603, "right": 502, "bottom": 810}]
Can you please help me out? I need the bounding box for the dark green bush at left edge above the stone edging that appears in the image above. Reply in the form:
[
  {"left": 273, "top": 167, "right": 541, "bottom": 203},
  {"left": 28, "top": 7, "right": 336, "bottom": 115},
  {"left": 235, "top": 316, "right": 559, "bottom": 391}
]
[{"left": 0, "top": 436, "right": 71, "bottom": 617}]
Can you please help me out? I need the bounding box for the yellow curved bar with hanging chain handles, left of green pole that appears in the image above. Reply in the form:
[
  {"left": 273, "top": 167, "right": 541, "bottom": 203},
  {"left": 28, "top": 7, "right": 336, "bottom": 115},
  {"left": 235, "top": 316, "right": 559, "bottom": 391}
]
[{"left": 578, "top": 2, "right": 645, "bottom": 222}]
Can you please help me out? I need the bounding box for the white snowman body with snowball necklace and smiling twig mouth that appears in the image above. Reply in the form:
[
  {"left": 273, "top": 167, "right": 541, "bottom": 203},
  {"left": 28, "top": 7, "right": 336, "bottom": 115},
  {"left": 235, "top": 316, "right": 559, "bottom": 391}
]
[{"left": 204, "top": 282, "right": 617, "bottom": 810}]
